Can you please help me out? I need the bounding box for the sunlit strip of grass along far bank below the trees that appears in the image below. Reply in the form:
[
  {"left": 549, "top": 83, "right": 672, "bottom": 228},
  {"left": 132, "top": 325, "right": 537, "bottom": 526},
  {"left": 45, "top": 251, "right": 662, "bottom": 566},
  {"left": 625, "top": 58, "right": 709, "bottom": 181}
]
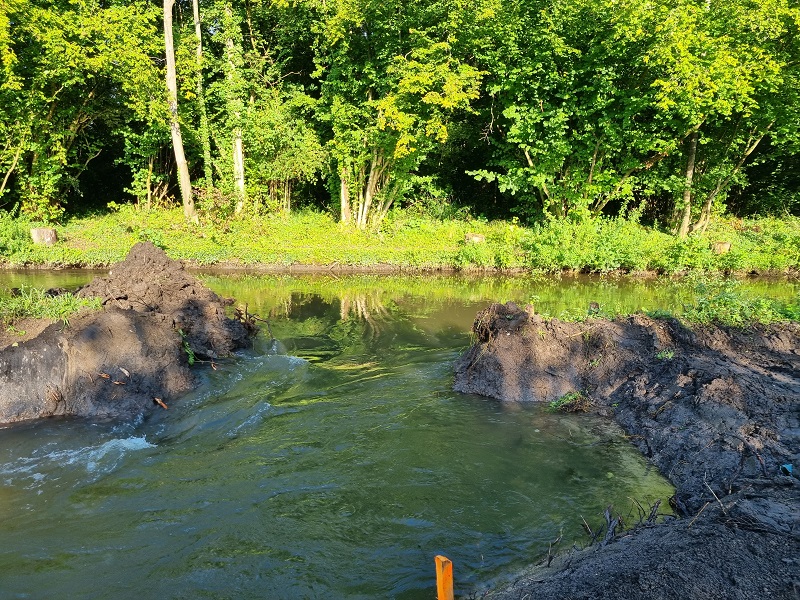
[{"left": 0, "top": 206, "right": 800, "bottom": 273}]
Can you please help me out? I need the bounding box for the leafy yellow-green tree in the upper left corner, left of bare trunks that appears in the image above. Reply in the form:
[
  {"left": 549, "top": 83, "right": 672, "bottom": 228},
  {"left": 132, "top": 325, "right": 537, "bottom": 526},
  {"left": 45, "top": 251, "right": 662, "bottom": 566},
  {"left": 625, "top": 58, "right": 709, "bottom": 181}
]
[{"left": 0, "top": 0, "right": 163, "bottom": 219}]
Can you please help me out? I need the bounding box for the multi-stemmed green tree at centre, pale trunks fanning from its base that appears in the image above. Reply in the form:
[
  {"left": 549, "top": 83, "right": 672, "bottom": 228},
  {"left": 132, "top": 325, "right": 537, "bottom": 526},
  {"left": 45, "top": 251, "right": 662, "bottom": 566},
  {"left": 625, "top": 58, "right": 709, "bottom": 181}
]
[{"left": 315, "top": 0, "right": 482, "bottom": 229}]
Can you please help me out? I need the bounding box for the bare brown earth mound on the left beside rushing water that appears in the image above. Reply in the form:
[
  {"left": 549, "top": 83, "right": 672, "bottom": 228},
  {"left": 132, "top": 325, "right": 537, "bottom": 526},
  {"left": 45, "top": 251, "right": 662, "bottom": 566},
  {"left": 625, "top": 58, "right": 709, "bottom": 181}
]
[{"left": 0, "top": 243, "right": 247, "bottom": 423}]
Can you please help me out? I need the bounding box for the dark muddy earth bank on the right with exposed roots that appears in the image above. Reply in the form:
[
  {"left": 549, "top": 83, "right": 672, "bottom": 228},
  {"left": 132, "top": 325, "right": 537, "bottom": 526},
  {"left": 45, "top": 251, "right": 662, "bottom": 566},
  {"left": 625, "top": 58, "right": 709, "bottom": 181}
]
[{"left": 455, "top": 303, "right": 800, "bottom": 600}]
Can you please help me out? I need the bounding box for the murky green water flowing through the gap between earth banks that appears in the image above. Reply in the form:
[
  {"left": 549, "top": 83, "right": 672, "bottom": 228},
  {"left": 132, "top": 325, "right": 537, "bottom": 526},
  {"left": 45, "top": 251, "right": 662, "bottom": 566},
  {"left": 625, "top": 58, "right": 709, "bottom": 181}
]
[{"left": 0, "top": 277, "right": 793, "bottom": 600}]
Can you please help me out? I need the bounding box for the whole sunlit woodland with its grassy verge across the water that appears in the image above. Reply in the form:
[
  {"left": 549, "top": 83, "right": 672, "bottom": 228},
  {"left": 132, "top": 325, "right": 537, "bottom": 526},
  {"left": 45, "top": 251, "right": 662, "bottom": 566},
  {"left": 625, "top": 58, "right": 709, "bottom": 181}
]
[{"left": 0, "top": 0, "right": 800, "bottom": 271}]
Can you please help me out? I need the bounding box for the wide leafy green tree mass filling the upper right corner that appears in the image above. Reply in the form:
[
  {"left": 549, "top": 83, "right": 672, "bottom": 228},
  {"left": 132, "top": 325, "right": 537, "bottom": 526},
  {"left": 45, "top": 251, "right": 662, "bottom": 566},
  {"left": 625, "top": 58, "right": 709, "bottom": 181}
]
[{"left": 473, "top": 0, "right": 797, "bottom": 230}]
